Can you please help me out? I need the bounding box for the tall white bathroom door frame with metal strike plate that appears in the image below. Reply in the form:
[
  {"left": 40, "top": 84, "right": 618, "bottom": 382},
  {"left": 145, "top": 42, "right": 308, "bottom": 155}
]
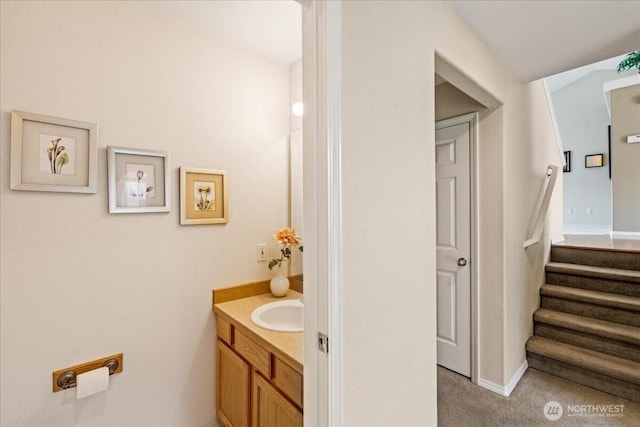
[{"left": 296, "top": 0, "right": 342, "bottom": 427}]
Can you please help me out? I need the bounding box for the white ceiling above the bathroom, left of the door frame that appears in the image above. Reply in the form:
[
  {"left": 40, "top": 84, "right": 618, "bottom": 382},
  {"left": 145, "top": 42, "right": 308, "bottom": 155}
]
[{"left": 142, "top": 0, "right": 302, "bottom": 64}]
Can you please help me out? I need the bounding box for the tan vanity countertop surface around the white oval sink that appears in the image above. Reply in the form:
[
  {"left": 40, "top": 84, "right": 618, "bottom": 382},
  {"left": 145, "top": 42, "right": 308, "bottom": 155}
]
[{"left": 213, "top": 289, "right": 304, "bottom": 373}]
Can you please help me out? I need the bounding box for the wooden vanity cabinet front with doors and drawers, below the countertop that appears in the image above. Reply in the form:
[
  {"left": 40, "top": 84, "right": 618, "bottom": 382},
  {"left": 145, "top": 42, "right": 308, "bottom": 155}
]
[{"left": 216, "top": 316, "right": 303, "bottom": 427}]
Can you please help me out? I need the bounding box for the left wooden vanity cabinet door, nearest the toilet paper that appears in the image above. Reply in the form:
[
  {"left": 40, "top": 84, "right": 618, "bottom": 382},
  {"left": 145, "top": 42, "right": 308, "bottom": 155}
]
[{"left": 216, "top": 340, "right": 251, "bottom": 427}]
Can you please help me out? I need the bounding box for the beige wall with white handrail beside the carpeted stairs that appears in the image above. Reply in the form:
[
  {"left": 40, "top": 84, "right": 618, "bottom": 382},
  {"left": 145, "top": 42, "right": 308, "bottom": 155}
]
[{"left": 504, "top": 80, "right": 562, "bottom": 387}]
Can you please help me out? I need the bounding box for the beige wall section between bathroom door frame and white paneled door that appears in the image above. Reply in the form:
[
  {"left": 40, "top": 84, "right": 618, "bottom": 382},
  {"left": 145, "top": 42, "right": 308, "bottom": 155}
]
[{"left": 342, "top": 1, "right": 437, "bottom": 427}]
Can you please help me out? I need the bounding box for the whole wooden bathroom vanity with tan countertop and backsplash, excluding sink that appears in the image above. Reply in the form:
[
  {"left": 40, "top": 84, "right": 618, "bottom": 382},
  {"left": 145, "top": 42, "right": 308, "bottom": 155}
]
[{"left": 213, "top": 282, "right": 303, "bottom": 427}]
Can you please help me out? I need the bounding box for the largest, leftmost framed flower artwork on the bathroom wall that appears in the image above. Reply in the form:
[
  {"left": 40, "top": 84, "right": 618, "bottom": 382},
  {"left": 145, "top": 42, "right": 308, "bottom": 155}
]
[{"left": 10, "top": 110, "right": 98, "bottom": 193}]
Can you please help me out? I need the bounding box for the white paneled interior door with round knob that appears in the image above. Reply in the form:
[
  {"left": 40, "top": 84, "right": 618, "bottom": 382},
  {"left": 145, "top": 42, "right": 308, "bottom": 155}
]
[{"left": 435, "top": 122, "right": 471, "bottom": 377}]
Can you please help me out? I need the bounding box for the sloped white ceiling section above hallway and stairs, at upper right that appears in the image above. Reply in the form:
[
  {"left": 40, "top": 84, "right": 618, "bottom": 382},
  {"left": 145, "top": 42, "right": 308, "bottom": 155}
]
[{"left": 451, "top": 0, "right": 640, "bottom": 82}]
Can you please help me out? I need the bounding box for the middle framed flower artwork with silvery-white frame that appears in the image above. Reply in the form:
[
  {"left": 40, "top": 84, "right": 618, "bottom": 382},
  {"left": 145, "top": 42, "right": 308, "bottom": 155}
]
[{"left": 107, "top": 146, "right": 171, "bottom": 213}]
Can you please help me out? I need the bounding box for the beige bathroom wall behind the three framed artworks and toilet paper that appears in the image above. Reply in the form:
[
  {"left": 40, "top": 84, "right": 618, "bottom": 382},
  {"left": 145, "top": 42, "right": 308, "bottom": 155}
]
[{"left": 0, "top": 1, "right": 289, "bottom": 427}]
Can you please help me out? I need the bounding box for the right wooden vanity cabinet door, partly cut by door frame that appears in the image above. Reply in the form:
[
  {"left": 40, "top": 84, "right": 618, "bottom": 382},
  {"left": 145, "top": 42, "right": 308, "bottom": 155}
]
[{"left": 252, "top": 372, "right": 302, "bottom": 427}]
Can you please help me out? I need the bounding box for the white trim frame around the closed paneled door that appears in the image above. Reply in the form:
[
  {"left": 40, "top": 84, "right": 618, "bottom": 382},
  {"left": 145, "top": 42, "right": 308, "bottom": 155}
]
[{"left": 435, "top": 112, "right": 480, "bottom": 384}]
